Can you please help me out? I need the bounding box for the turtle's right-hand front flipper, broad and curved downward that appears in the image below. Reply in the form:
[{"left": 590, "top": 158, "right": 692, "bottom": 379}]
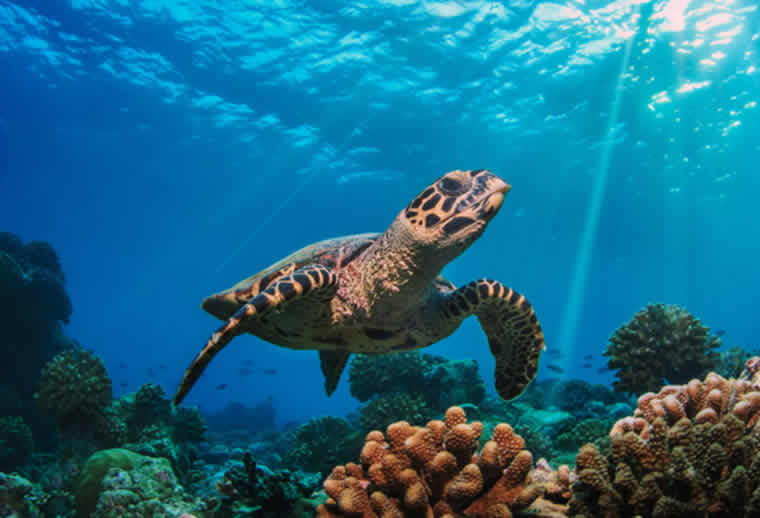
[{"left": 444, "top": 279, "right": 544, "bottom": 399}]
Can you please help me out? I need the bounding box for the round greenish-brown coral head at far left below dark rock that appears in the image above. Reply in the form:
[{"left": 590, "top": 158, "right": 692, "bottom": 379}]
[{"left": 37, "top": 349, "right": 111, "bottom": 424}]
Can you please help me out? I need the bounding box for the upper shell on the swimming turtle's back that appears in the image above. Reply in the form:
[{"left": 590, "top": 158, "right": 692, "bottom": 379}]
[{"left": 201, "top": 232, "right": 380, "bottom": 320}]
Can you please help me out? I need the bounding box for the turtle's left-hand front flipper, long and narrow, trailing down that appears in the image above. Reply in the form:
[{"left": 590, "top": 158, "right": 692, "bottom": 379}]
[{"left": 174, "top": 264, "right": 337, "bottom": 405}]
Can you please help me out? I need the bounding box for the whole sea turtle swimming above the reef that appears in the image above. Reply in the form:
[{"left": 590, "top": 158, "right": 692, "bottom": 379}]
[{"left": 174, "top": 169, "right": 544, "bottom": 405}]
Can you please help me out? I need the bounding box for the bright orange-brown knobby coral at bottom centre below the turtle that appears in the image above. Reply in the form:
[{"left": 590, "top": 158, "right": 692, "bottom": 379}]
[{"left": 317, "top": 407, "right": 569, "bottom": 518}]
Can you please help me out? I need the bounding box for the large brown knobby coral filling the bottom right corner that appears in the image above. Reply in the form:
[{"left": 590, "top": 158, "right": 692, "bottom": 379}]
[{"left": 569, "top": 373, "right": 760, "bottom": 518}]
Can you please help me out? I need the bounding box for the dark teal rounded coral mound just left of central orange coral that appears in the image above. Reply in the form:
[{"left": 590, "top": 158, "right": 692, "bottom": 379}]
[{"left": 283, "top": 416, "right": 362, "bottom": 480}]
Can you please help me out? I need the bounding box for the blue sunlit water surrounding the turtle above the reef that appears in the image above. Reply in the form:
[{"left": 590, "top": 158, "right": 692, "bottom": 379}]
[{"left": 0, "top": 0, "right": 760, "bottom": 422}]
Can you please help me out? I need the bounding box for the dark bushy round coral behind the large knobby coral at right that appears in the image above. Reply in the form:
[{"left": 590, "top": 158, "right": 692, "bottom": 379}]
[{"left": 604, "top": 304, "right": 721, "bottom": 394}]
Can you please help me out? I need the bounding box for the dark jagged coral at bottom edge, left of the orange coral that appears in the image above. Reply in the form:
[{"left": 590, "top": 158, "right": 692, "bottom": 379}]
[{"left": 210, "top": 453, "right": 319, "bottom": 518}]
